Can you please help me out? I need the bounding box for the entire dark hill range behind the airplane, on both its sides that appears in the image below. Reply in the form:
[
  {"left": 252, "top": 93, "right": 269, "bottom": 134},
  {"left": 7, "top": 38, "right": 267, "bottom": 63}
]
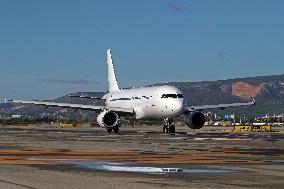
[{"left": 0, "top": 74, "right": 284, "bottom": 118}]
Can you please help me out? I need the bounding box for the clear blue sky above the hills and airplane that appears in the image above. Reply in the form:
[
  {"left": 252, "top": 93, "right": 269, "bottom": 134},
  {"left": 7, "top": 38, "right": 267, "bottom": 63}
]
[{"left": 0, "top": 0, "right": 284, "bottom": 99}]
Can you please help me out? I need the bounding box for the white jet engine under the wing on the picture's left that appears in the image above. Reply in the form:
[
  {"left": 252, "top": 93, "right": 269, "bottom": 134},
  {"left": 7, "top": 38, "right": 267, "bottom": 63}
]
[{"left": 97, "top": 111, "right": 118, "bottom": 127}]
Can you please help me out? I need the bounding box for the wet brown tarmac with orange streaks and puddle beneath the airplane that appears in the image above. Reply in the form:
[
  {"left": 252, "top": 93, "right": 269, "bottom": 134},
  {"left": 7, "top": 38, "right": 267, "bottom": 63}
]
[{"left": 0, "top": 126, "right": 284, "bottom": 189}]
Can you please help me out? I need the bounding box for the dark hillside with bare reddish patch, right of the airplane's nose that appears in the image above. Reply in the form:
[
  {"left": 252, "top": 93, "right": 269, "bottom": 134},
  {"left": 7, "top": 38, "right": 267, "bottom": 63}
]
[{"left": 158, "top": 74, "right": 284, "bottom": 114}]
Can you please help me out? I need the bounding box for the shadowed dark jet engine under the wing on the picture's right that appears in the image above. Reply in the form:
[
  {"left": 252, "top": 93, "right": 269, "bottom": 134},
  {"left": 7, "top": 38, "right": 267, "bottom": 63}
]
[{"left": 185, "top": 112, "right": 205, "bottom": 129}]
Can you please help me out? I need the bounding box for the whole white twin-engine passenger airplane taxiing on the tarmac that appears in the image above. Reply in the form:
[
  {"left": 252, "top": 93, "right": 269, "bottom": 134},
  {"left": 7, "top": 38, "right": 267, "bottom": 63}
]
[{"left": 10, "top": 49, "right": 255, "bottom": 134}]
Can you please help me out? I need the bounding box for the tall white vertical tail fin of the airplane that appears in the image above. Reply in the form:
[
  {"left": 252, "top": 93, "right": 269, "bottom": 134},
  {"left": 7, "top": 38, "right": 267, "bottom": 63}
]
[{"left": 107, "top": 49, "right": 119, "bottom": 92}]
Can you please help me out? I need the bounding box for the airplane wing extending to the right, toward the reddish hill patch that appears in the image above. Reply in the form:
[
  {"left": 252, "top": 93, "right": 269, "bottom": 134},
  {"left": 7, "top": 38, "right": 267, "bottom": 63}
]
[{"left": 186, "top": 100, "right": 255, "bottom": 112}]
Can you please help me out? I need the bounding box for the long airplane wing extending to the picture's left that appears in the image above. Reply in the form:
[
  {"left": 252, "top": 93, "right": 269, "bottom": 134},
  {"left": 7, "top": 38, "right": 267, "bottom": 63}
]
[{"left": 9, "top": 100, "right": 134, "bottom": 114}]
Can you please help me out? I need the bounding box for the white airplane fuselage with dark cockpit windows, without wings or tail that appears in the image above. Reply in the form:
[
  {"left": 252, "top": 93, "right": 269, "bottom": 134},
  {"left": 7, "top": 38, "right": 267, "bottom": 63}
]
[{"left": 104, "top": 86, "right": 184, "bottom": 120}]
